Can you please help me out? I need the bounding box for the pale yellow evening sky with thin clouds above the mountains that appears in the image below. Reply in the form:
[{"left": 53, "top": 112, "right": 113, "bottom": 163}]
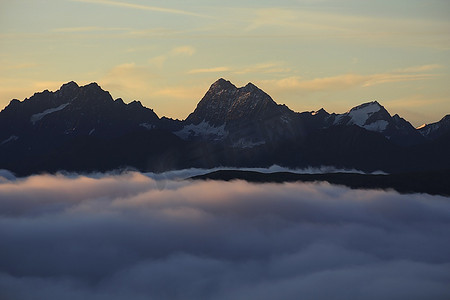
[{"left": 0, "top": 0, "right": 450, "bottom": 126}]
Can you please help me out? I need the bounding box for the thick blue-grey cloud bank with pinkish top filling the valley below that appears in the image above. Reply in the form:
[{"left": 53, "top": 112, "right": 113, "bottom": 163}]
[{"left": 0, "top": 173, "right": 450, "bottom": 300}]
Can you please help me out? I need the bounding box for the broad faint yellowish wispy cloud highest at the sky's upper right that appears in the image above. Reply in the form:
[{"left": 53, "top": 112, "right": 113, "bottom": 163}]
[{"left": 244, "top": 8, "right": 450, "bottom": 49}]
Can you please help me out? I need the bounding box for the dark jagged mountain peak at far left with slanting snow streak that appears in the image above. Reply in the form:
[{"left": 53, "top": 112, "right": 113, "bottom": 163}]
[{"left": 0, "top": 81, "right": 159, "bottom": 134}]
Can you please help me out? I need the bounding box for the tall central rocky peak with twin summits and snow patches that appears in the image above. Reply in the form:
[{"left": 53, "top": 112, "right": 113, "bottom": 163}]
[{"left": 178, "top": 79, "right": 301, "bottom": 148}]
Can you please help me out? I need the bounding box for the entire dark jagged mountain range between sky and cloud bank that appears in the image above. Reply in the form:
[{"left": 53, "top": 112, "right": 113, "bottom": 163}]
[{"left": 0, "top": 79, "right": 450, "bottom": 175}]
